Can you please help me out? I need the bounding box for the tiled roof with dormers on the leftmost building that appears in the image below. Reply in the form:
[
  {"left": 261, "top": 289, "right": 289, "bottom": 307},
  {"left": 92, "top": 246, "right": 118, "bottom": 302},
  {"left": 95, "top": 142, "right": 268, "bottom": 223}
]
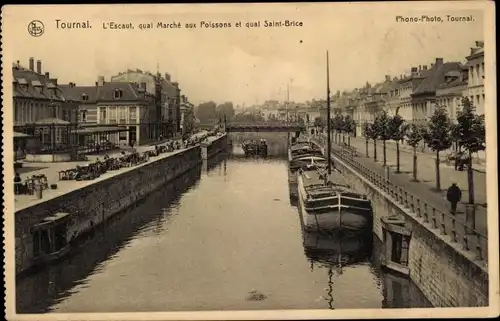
[{"left": 12, "top": 65, "right": 68, "bottom": 101}]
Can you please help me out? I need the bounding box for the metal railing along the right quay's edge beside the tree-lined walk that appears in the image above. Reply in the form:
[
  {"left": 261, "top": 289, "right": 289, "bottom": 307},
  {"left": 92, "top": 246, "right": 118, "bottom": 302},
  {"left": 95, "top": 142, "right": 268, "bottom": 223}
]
[{"left": 314, "top": 132, "right": 488, "bottom": 263}]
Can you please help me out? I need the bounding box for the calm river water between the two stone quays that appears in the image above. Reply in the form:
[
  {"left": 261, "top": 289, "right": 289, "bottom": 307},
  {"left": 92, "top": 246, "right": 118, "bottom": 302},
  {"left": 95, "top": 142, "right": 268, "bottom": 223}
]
[{"left": 16, "top": 146, "right": 430, "bottom": 313}]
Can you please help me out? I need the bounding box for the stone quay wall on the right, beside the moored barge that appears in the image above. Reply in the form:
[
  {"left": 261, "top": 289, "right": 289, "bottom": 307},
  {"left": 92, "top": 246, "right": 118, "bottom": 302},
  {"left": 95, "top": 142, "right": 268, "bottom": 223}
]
[{"left": 314, "top": 139, "right": 489, "bottom": 307}]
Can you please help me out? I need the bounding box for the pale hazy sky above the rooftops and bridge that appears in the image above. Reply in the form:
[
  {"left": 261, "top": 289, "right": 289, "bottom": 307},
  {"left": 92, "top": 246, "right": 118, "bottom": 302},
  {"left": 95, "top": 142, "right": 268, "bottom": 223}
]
[{"left": 2, "top": 2, "right": 486, "bottom": 106}]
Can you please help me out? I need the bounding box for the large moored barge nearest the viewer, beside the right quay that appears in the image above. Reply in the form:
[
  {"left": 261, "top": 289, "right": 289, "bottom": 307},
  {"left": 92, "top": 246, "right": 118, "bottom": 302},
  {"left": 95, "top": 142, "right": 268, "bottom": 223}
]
[{"left": 297, "top": 166, "right": 373, "bottom": 233}]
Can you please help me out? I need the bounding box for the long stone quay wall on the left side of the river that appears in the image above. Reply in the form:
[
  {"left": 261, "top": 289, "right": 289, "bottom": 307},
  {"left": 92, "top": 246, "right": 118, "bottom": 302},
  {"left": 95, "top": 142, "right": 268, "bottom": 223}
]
[{"left": 15, "top": 145, "right": 202, "bottom": 274}]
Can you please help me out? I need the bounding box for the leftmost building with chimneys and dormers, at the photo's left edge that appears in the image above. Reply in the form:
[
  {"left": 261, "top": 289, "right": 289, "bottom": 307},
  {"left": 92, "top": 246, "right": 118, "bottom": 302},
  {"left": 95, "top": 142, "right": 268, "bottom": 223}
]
[{"left": 12, "top": 57, "right": 78, "bottom": 159}]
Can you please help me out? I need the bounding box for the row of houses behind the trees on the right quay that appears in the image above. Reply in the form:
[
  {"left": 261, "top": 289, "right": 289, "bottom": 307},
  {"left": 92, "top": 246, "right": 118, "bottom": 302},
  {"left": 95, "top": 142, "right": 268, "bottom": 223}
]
[{"left": 321, "top": 41, "right": 485, "bottom": 133}]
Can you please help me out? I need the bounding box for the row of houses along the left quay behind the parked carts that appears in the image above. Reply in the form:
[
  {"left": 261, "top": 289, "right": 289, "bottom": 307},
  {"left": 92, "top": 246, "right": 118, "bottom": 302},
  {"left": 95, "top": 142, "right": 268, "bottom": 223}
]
[{"left": 12, "top": 58, "right": 193, "bottom": 151}]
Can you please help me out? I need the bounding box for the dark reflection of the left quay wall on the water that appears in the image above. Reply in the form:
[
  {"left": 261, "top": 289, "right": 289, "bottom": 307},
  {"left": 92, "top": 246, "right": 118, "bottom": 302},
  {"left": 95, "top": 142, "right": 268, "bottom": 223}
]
[{"left": 16, "top": 164, "right": 205, "bottom": 313}]
